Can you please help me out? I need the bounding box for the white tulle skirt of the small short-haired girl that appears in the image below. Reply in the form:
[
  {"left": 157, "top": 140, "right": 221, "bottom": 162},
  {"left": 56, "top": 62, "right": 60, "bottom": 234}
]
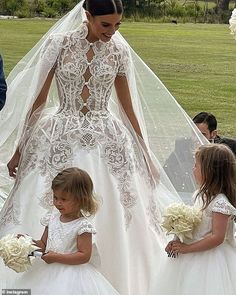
[{"left": 12, "top": 258, "right": 119, "bottom": 295}]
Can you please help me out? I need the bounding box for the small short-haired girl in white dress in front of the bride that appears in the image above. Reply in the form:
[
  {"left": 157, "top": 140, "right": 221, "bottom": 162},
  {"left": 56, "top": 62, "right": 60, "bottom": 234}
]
[{"left": 13, "top": 168, "right": 119, "bottom": 295}]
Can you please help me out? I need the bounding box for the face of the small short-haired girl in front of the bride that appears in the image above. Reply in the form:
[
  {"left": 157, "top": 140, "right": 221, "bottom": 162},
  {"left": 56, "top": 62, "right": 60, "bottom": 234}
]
[{"left": 53, "top": 189, "right": 79, "bottom": 217}]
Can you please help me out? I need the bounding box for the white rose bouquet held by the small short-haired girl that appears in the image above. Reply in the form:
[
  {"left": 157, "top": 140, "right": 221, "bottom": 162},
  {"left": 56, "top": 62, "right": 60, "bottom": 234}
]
[{"left": 0, "top": 234, "right": 38, "bottom": 272}]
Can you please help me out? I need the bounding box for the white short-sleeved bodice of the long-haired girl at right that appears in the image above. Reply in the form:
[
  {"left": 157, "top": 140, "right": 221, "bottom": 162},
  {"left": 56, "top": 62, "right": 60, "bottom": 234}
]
[{"left": 192, "top": 194, "right": 236, "bottom": 246}]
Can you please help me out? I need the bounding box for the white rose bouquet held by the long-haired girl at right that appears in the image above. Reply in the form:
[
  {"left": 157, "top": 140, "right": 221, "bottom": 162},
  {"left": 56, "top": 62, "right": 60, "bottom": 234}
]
[{"left": 162, "top": 203, "right": 202, "bottom": 242}]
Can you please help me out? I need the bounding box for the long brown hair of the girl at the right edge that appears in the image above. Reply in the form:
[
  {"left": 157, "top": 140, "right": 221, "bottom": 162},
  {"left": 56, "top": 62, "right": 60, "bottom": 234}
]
[{"left": 195, "top": 143, "right": 236, "bottom": 208}]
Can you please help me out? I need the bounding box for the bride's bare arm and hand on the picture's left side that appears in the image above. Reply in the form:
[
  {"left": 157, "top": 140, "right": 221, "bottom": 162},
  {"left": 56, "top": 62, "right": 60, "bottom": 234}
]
[{"left": 7, "top": 67, "right": 55, "bottom": 177}]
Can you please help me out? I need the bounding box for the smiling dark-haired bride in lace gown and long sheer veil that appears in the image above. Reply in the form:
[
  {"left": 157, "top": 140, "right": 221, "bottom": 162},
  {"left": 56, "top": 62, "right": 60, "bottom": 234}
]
[{"left": 0, "top": 0, "right": 206, "bottom": 295}]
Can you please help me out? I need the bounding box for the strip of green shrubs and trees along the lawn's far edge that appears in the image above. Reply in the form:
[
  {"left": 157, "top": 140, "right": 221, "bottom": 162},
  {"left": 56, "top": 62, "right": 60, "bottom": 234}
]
[{"left": 0, "top": 0, "right": 236, "bottom": 23}]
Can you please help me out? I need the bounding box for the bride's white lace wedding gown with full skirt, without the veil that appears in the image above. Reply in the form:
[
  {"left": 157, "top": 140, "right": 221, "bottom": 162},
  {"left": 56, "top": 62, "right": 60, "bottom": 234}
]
[{"left": 0, "top": 24, "right": 173, "bottom": 295}]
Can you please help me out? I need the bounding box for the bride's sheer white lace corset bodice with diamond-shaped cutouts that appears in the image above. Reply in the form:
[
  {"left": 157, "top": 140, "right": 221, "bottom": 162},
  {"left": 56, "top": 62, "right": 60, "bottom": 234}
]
[{"left": 55, "top": 23, "right": 129, "bottom": 115}]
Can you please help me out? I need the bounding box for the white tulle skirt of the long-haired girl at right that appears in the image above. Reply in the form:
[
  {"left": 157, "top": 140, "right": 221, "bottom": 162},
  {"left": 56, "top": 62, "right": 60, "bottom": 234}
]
[{"left": 149, "top": 243, "right": 236, "bottom": 295}]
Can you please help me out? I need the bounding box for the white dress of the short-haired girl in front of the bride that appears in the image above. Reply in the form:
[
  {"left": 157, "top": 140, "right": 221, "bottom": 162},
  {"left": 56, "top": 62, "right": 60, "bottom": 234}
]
[{"left": 13, "top": 214, "right": 119, "bottom": 295}]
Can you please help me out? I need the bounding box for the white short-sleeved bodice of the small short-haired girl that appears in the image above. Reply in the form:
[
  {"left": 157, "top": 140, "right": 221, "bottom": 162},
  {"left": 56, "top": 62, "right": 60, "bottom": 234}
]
[{"left": 44, "top": 214, "right": 96, "bottom": 253}]
